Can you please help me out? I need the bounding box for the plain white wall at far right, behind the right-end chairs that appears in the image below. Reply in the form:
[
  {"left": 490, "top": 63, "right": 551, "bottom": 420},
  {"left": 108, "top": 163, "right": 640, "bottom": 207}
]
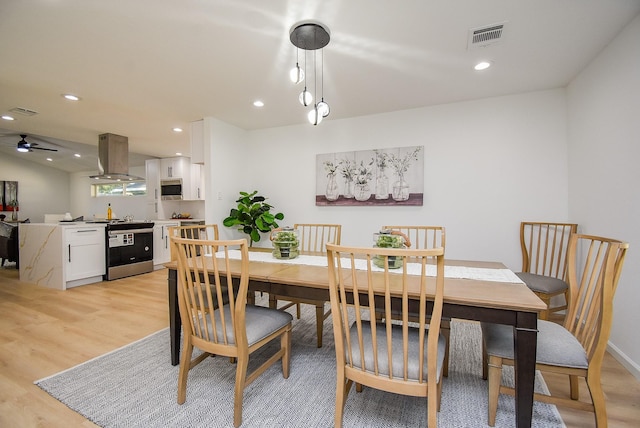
[{"left": 568, "top": 15, "right": 640, "bottom": 378}]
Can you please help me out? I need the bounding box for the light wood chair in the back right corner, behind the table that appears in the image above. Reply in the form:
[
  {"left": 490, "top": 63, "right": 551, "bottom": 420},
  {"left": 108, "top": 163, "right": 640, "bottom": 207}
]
[{"left": 516, "top": 221, "right": 578, "bottom": 320}]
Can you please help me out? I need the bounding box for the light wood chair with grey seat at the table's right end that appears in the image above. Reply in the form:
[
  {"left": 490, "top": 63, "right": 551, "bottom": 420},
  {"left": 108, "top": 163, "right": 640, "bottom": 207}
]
[{"left": 481, "top": 234, "right": 629, "bottom": 428}]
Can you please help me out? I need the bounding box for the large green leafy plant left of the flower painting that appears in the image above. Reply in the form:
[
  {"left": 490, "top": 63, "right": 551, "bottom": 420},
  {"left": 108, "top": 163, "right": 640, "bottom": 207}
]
[{"left": 222, "top": 190, "right": 284, "bottom": 246}]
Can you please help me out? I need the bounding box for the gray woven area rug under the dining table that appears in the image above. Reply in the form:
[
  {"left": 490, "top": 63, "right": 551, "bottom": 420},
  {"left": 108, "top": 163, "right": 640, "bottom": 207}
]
[{"left": 35, "top": 305, "right": 565, "bottom": 428}]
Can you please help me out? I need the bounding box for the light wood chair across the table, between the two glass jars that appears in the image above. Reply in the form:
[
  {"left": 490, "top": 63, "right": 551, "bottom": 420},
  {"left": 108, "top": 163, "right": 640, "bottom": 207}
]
[{"left": 269, "top": 223, "right": 342, "bottom": 348}]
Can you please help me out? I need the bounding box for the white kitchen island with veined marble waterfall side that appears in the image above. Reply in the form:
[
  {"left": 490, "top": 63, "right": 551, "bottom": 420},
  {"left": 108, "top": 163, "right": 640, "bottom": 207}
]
[{"left": 18, "top": 222, "right": 106, "bottom": 290}]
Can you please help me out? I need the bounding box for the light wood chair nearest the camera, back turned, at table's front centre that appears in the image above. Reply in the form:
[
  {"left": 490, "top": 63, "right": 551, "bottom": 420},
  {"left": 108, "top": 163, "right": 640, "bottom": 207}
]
[{"left": 327, "top": 244, "right": 445, "bottom": 427}]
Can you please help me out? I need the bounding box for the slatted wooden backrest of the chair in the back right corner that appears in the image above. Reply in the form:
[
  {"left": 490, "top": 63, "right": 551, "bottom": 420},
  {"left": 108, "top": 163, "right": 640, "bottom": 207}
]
[{"left": 520, "top": 221, "right": 578, "bottom": 280}]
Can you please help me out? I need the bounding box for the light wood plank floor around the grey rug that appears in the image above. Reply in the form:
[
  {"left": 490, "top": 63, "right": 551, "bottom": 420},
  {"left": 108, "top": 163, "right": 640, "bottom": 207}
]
[{"left": 0, "top": 268, "right": 640, "bottom": 428}]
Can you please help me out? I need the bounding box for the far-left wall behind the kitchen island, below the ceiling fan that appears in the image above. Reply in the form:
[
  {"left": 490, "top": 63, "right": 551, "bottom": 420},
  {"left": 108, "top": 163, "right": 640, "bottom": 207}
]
[{"left": 0, "top": 153, "right": 70, "bottom": 223}]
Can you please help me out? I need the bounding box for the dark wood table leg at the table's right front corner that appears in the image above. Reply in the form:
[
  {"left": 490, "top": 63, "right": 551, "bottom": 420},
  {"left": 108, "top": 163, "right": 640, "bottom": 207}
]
[{"left": 513, "top": 312, "right": 538, "bottom": 428}]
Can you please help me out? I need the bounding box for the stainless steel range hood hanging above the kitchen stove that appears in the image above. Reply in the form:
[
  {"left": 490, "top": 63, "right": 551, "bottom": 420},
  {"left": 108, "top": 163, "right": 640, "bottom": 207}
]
[{"left": 91, "top": 133, "right": 143, "bottom": 181}]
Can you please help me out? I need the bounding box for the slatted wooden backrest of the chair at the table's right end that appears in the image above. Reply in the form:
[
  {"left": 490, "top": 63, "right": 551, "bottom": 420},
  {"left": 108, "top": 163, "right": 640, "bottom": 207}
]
[{"left": 564, "top": 234, "right": 629, "bottom": 360}]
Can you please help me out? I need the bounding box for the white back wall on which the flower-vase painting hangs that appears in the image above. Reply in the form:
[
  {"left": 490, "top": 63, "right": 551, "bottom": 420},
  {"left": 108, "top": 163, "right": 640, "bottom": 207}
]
[{"left": 241, "top": 89, "right": 568, "bottom": 270}]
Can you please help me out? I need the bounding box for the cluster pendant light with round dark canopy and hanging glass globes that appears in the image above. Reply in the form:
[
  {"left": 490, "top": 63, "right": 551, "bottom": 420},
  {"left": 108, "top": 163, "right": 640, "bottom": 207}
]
[{"left": 289, "top": 21, "right": 331, "bottom": 125}]
